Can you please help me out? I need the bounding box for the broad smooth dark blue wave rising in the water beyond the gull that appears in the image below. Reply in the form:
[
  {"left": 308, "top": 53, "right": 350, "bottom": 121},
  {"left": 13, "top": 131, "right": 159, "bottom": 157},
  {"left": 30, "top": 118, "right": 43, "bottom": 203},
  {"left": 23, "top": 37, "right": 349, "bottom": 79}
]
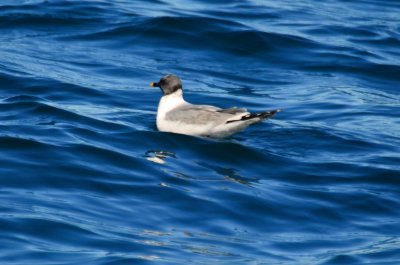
[{"left": 63, "top": 17, "right": 322, "bottom": 58}]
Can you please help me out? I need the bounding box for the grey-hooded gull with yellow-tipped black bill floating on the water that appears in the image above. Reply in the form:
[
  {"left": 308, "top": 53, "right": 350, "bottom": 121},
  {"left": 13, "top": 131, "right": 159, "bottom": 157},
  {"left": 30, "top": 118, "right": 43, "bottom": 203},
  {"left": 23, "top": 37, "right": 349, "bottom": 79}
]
[{"left": 150, "top": 74, "right": 280, "bottom": 138}]
